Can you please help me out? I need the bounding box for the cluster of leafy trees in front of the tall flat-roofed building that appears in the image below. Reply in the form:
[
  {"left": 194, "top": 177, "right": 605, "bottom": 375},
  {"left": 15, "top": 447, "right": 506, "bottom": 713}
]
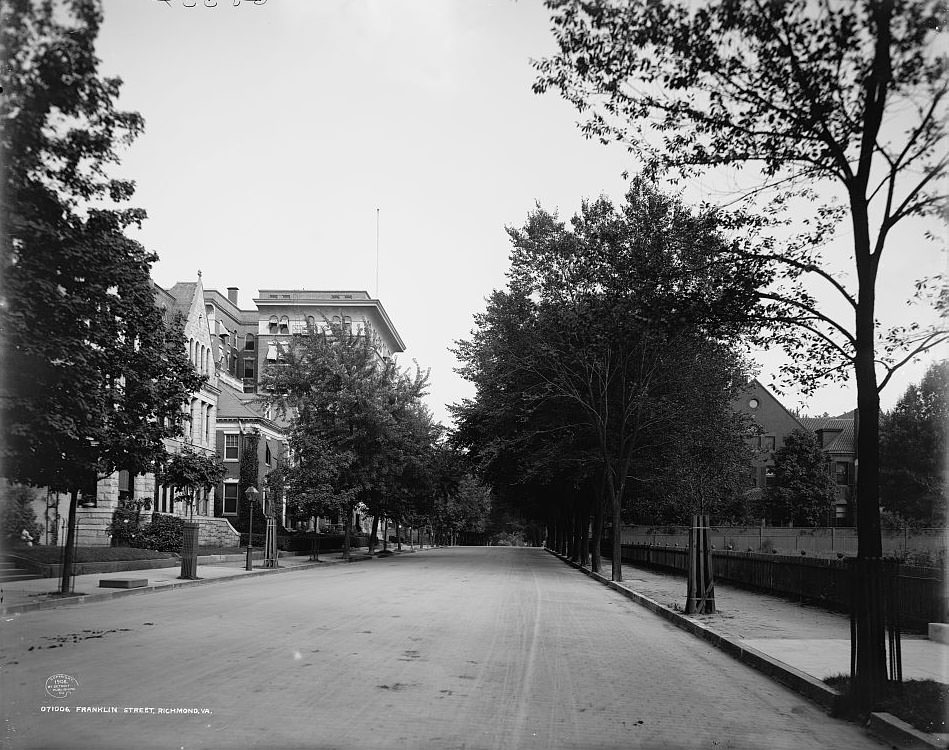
[{"left": 261, "top": 320, "right": 490, "bottom": 556}]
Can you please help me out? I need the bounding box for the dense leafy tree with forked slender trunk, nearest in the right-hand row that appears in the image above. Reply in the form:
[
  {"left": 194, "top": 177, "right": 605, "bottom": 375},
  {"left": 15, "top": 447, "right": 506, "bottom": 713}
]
[{"left": 459, "top": 179, "right": 759, "bottom": 580}]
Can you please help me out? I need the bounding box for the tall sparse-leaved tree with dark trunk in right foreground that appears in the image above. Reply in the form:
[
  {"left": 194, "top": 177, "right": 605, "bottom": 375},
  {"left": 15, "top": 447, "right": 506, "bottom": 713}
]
[{"left": 535, "top": 0, "right": 949, "bottom": 708}]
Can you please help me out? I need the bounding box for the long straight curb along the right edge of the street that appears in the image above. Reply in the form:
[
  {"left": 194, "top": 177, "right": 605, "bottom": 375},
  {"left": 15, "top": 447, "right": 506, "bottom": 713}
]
[{"left": 545, "top": 547, "right": 947, "bottom": 750}]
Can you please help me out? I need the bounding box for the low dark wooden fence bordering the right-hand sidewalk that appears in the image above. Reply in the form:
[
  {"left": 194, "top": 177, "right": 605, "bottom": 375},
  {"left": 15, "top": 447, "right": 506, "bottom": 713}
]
[{"left": 616, "top": 544, "right": 949, "bottom": 631}]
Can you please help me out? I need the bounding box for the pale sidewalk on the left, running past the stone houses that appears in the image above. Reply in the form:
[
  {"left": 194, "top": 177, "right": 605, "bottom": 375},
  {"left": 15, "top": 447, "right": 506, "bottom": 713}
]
[{"left": 0, "top": 549, "right": 422, "bottom": 615}]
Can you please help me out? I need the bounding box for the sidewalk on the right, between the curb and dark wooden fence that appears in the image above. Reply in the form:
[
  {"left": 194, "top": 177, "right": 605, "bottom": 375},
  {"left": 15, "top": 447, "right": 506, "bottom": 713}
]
[{"left": 554, "top": 553, "right": 949, "bottom": 748}]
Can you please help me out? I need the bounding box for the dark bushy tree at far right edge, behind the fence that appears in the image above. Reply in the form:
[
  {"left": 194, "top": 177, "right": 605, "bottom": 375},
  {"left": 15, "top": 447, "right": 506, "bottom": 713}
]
[{"left": 880, "top": 360, "right": 949, "bottom": 525}]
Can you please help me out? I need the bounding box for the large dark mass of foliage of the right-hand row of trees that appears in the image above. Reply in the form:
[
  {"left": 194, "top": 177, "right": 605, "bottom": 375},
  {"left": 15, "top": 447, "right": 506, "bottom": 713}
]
[{"left": 454, "top": 179, "right": 759, "bottom": 579}]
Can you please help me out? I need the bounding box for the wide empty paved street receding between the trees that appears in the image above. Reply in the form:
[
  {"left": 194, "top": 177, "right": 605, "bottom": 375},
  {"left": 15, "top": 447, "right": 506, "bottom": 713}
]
[{"left": 0, "top": 547, "right": 880, "bottom": 750}]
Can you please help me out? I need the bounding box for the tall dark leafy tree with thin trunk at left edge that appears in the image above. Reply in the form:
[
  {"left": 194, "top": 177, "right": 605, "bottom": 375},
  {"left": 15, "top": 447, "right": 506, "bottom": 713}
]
[{"left": 0, "top": 0, "right": 201, "bottom": 591}]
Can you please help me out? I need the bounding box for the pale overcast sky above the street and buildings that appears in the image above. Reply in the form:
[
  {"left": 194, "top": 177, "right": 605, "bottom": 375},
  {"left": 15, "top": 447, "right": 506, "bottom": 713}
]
[{"left": 99, "top": 0, "right": 945, "bottom": 424}]
